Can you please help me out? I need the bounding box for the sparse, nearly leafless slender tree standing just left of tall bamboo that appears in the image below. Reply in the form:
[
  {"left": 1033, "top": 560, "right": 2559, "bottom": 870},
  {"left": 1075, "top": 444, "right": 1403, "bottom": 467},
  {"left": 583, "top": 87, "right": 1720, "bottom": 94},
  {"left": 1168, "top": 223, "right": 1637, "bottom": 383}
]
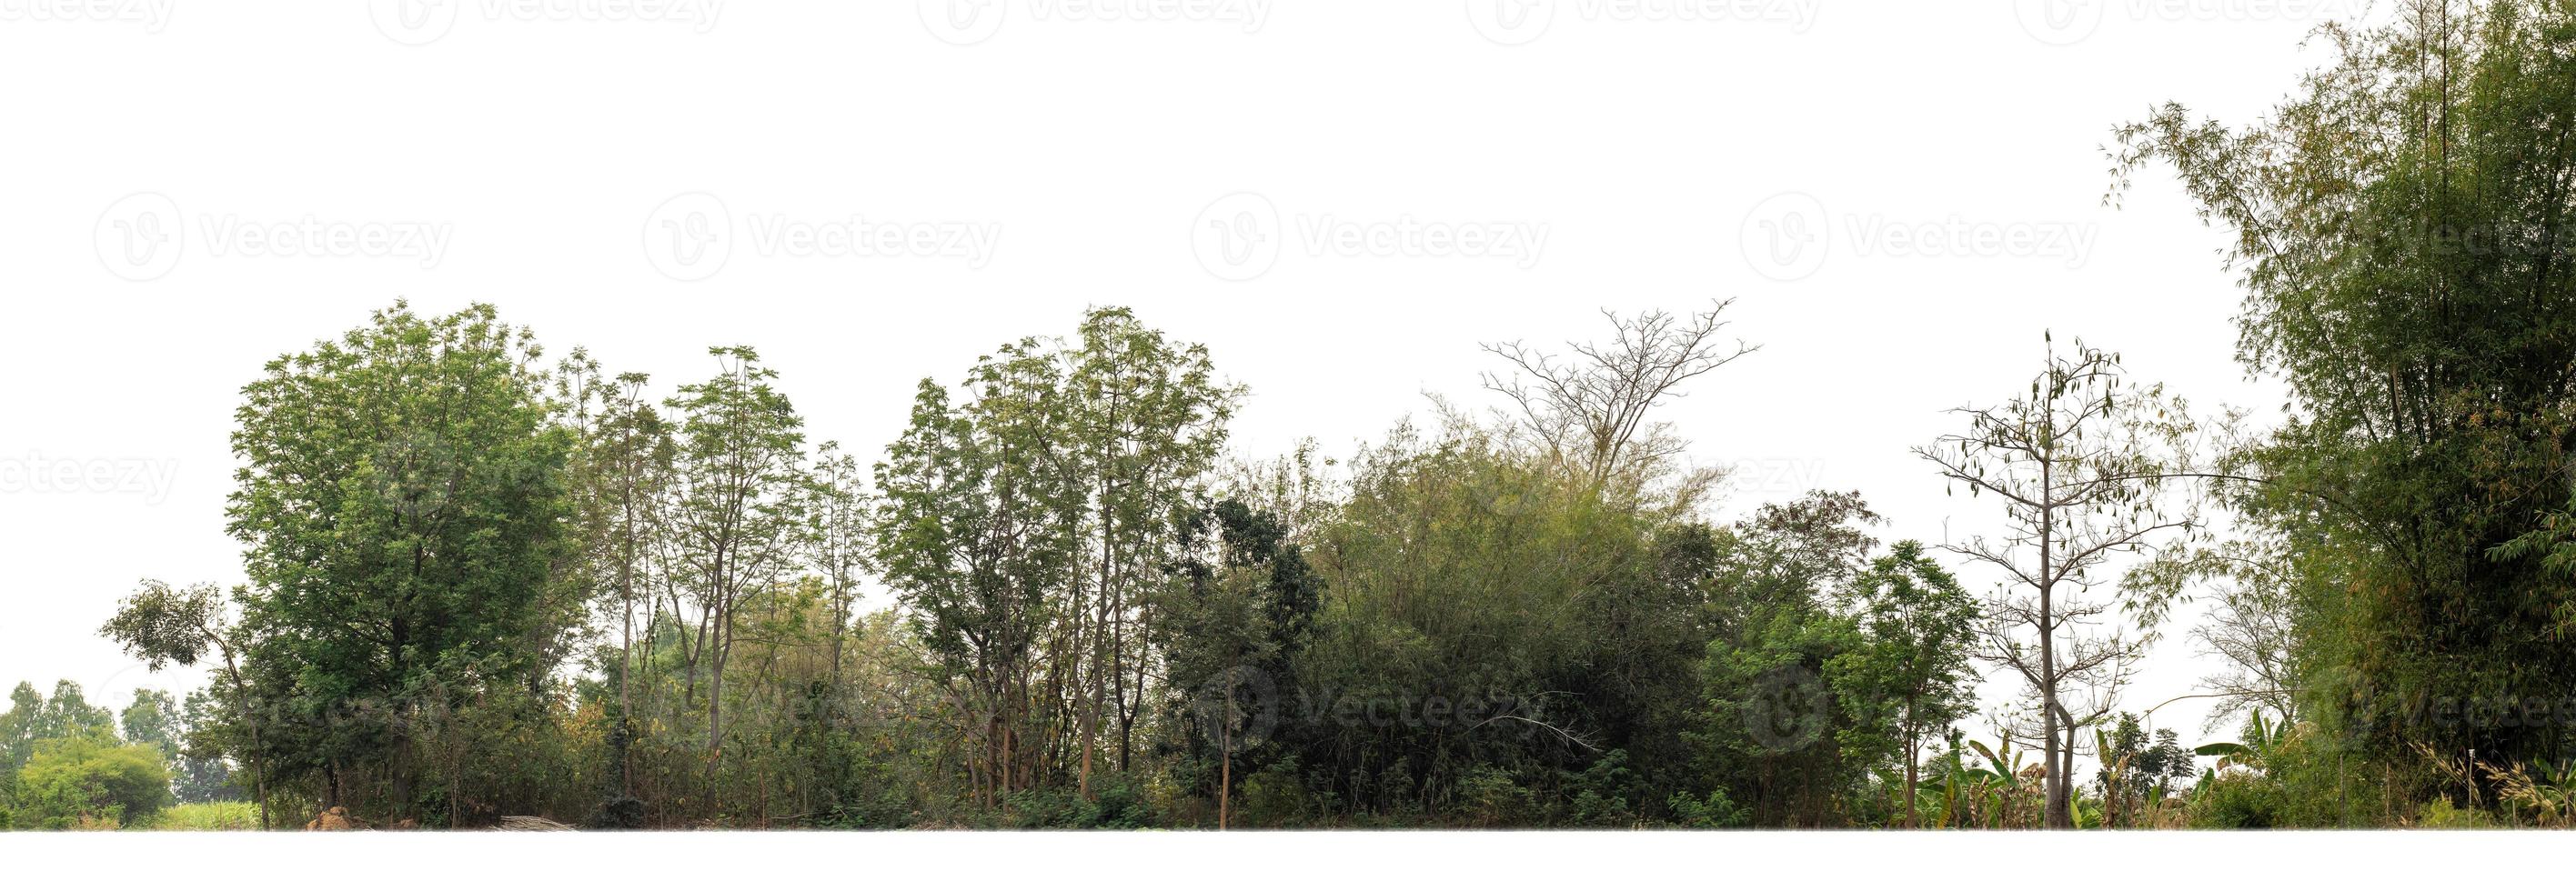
[{"left": 1914, "top": 340, "right": 2200, "bottom": 829}]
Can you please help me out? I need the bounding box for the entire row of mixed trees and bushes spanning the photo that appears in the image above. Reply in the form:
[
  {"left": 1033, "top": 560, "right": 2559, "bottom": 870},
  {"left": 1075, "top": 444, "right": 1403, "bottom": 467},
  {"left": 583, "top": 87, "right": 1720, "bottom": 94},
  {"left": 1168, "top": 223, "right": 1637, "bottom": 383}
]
[{"left": 0, "top": 0, "right": 2576, "bottom": 829}]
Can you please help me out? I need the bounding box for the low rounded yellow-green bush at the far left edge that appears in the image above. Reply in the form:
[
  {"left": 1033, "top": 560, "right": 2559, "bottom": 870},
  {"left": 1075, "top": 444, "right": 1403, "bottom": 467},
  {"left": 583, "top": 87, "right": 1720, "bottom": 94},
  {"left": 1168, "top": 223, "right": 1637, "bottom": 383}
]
[{"left": 13, "top": 736, "right": 170, "bottom": 829}]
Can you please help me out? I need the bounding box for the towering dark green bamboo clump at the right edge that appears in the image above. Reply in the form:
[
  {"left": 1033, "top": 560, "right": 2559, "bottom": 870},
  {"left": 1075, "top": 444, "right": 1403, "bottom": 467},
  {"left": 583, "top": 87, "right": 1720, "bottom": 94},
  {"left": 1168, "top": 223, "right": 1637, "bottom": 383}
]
[{"left": 2112, "top": 0, "right": 2576, "bottom": 804}]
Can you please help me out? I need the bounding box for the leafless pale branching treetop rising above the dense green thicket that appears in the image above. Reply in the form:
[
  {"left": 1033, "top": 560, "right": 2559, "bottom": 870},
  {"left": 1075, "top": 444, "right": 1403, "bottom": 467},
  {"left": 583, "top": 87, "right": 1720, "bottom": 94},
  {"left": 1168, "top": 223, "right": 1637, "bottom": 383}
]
[{"left": 1484, "top": 299, "right": 1759, "bottom": 489}]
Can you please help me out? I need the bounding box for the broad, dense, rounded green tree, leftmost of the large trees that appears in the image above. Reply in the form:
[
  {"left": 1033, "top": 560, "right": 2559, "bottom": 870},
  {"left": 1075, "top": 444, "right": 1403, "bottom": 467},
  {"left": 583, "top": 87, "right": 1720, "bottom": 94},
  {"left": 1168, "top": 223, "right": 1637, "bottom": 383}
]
[{"left": 229, "top": 304, "right": 569, "bottom": 814}]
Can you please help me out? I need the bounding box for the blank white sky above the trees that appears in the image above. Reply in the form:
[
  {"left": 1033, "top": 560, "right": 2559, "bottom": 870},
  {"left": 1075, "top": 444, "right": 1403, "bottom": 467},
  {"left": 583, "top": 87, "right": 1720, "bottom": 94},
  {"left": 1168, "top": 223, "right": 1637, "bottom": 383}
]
[{"left": 0, "top": 0, "right": 2368, "bottom": 742}]
